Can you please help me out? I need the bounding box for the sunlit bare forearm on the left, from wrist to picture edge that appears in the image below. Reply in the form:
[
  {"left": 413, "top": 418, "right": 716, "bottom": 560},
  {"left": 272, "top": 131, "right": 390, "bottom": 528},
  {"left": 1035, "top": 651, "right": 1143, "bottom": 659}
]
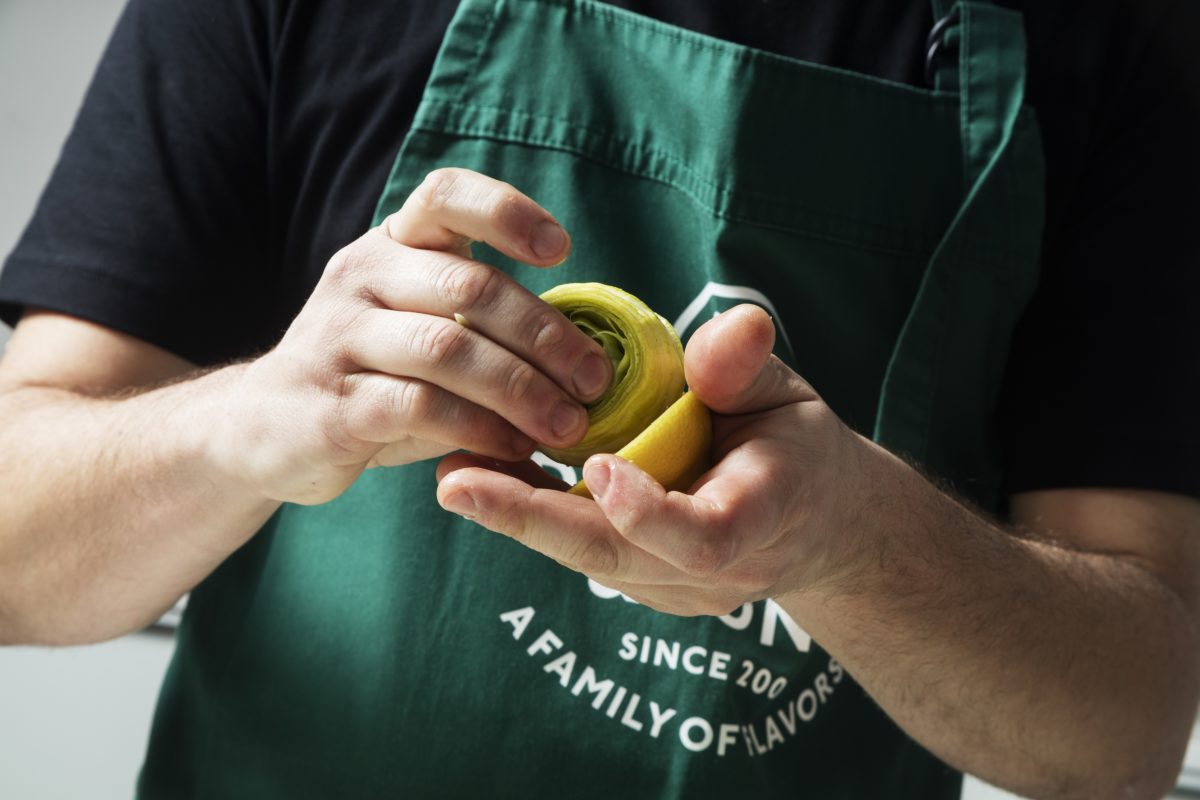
[{"left": 0, "top": 367, "right": 278, "bottom": 643}]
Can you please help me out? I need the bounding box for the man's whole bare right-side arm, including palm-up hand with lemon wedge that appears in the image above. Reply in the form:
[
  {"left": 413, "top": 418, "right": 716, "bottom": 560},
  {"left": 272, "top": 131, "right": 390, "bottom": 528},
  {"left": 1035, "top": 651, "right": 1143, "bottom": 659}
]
[{"left": 438, "top": 307, "right": 1200, "bottom": 800}]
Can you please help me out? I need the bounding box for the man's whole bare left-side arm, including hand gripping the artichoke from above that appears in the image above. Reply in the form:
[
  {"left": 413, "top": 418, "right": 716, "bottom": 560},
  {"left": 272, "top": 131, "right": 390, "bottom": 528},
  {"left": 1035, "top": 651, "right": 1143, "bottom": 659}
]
[{"left": 0, "top": 170, "right": 612, "bottom": 644}]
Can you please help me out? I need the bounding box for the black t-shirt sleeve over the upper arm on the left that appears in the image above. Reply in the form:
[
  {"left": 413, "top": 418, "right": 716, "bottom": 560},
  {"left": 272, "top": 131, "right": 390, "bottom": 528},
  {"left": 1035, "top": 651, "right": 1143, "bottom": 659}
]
[{"left": 0, "top": 0, "right": 275, "bottom": 365}]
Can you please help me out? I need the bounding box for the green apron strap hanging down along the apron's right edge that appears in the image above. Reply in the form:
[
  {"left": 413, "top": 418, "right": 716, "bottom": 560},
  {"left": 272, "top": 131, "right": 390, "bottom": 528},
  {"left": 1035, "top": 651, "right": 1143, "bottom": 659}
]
[{"left": 873, "top": 2, "right": 1043, "bottom": 509}]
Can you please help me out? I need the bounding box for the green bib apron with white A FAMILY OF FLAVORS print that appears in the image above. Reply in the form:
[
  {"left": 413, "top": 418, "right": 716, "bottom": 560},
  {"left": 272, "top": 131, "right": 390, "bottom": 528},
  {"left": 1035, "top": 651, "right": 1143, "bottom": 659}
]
[{"left": 139, "top": 0, "right": 1043, "bottom": 800}]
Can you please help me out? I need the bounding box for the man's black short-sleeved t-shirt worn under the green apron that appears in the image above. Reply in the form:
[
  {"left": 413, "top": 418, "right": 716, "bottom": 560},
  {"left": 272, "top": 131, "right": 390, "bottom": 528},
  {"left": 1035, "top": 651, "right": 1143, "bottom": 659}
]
[{"left": 0, "top": 0, "right": 1200, "bottom": 497}]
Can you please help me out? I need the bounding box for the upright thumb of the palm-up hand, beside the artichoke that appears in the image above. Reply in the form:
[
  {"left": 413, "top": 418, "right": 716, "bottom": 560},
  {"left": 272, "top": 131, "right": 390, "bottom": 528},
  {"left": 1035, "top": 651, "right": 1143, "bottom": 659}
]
[{"left": 684, "top": 305, "right": 817, "bottom": 414}]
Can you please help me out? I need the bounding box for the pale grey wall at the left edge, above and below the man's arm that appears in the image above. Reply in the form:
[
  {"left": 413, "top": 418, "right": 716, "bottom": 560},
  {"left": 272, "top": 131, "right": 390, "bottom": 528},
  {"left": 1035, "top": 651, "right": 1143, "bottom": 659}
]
[{"left": 0, "top": 0, "right": 172, "bottom": 800}]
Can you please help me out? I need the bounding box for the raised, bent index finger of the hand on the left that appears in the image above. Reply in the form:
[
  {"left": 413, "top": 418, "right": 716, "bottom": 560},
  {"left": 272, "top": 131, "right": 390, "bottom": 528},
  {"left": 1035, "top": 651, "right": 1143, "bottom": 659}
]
[{"left": 380, "top": 168, "right": 571, "bottom": 266}]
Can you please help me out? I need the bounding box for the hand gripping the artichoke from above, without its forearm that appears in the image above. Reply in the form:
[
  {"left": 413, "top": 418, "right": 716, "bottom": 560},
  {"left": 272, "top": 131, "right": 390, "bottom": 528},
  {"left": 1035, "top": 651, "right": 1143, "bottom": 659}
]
[{"left": 214, "top": 169, "right": 612, "bottom": 504}]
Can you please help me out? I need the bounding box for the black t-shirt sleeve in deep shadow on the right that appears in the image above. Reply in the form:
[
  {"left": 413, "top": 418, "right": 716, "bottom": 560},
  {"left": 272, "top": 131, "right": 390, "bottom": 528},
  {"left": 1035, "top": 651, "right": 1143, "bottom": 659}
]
[{"left": 1002, "top": 2, "right": 1200, "bottom": 497}]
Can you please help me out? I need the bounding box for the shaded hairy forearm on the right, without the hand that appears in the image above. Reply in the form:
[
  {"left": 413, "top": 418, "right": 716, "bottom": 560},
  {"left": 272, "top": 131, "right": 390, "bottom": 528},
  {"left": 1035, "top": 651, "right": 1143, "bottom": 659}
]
[{"left": 780, "top": 446, "right": 1200, "bottom": 798}]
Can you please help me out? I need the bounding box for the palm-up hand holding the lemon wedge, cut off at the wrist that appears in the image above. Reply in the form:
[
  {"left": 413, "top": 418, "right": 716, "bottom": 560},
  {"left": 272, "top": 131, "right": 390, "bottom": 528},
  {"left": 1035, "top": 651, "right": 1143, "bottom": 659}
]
[{"left": 438, "top": 306, "right": 858, "bottom": 615}]
